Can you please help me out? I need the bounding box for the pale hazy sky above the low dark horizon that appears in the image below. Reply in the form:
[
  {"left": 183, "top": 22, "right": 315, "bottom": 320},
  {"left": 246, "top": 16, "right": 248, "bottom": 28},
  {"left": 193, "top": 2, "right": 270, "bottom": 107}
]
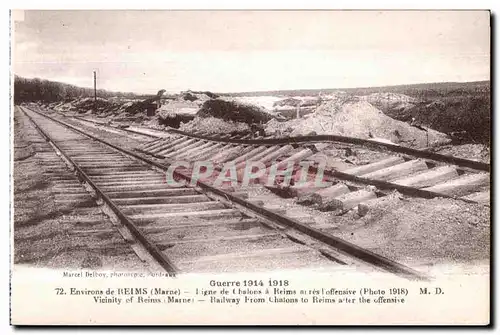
[{"left": 12, "top": 10, "right": 490, "bottom": 94}]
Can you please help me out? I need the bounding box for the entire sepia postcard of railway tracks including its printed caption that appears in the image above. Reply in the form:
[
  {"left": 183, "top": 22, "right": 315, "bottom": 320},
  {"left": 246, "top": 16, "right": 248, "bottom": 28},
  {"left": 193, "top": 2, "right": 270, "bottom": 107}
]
[{"left": 10, "top": 10, "right": 492, "bottom": 325}]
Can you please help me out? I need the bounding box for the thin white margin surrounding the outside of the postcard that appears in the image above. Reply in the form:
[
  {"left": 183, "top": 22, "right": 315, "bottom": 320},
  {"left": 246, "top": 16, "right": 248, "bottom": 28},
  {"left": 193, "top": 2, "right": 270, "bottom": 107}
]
[{"left": 0, "top": 0, "right": 500, "bottom": 333}]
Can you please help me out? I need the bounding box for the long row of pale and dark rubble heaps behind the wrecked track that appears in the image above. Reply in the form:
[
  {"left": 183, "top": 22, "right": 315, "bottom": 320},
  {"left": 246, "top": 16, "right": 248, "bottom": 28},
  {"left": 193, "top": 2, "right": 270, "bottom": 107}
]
[{"left": 38, "top": 86, "right": 464, "bottom": 148}]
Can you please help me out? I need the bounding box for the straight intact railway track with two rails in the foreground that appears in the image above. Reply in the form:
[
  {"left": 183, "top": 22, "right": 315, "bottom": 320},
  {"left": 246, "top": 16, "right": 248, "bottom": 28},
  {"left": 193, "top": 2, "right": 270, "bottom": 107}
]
[{"left": 17, "top": 107, "right": 426, "bottom": 279}]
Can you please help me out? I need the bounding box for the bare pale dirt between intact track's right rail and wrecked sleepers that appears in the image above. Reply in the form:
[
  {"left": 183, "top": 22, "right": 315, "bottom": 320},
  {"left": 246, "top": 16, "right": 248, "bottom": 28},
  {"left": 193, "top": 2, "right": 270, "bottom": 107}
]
[{"left": 249, "top": 186, "right": 491, "bottom": 271}]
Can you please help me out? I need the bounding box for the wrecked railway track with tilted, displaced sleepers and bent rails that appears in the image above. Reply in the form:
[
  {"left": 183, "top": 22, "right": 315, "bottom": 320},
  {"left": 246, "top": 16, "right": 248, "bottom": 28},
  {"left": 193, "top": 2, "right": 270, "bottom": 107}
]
[{"left": 61, "top": 111, "right": 490, "bottom": 215}]
